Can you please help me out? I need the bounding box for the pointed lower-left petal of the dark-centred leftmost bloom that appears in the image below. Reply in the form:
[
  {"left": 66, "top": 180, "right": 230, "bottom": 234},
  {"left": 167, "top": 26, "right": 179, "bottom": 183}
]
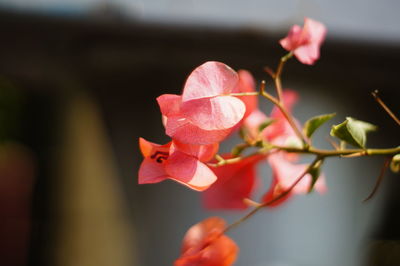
[{"left": 138, "top": 158, "right": 169, "bottom": 184}]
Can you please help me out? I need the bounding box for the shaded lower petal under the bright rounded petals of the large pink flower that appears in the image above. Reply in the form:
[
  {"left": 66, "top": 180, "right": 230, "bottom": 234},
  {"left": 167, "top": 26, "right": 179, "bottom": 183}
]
[{"left": 165, "top": 116, "right": 231, "bottom": 145}]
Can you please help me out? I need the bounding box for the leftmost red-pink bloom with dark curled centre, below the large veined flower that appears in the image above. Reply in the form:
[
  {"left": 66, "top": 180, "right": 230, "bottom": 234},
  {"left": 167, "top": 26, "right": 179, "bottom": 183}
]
[{"left": 139, "top": 138, "right": 218, "bottom": 191}]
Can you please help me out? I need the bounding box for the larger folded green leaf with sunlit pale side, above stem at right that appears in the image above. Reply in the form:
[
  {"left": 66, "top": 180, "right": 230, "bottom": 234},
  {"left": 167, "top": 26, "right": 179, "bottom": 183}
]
[{"left": 330, "top": 117, "right": 377, "bottom": 148}]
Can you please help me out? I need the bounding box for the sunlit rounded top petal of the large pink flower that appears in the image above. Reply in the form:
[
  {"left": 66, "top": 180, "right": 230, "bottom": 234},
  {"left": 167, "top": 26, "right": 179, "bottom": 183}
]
[{"left": 182, "top": 61, "right": 238, "bottom": 102}]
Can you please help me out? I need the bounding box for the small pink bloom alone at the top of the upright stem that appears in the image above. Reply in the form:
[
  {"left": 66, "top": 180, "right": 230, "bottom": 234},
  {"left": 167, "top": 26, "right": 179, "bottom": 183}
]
[{"left": 280, "top": 18, "right": 326, "bottom": 65}]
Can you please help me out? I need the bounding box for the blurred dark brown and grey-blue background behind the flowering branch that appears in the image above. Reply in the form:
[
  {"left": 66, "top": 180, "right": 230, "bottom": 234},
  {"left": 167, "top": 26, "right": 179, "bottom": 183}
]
[{"left": 0, "top": 0, "right": 400, "bottom": 266}]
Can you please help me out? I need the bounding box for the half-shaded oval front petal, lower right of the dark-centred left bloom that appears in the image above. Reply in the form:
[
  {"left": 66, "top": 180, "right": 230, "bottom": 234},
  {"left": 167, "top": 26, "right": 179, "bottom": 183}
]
[{"left": 165, "top": 151, "right": 217, "bottom": 191}]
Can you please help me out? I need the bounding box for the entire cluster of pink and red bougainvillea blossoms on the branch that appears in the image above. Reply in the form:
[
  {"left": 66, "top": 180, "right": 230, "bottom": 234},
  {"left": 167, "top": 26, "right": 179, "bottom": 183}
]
[{"left": 139, "top": 18, "right": 326, "bottom": 266}]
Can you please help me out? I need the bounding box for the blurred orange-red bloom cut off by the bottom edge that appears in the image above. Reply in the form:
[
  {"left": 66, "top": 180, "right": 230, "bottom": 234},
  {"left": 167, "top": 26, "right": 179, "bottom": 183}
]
[{"left": 174, "top": 217, "right": 239, "bottom": 266}]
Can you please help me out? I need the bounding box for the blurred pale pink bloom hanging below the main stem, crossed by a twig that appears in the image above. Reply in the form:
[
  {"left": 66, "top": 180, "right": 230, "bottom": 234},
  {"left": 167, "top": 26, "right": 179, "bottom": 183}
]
[{"left": 263, "top": 152, "right": 326, "bottom": 207}]
